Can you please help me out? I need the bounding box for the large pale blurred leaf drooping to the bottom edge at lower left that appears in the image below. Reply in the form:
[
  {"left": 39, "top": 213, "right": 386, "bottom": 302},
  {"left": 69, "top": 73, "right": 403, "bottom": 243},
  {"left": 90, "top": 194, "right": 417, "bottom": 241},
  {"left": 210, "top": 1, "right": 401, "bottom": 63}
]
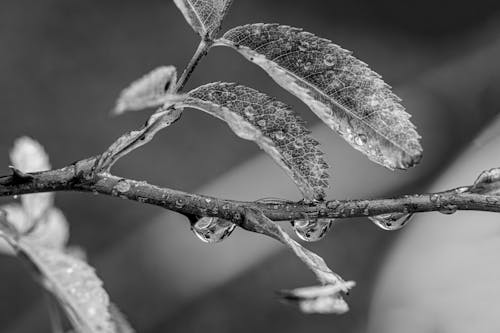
[{"left": 16, "top": 236, "right": 116, "bottom": 333}]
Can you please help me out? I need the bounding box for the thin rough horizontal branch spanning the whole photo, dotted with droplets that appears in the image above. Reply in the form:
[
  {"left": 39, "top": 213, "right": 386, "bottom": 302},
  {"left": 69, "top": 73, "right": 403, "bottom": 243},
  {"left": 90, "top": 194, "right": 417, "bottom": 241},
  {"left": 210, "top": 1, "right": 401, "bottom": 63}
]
[{"left": 0, "top": 157, "right": 500, "bottom": 223}]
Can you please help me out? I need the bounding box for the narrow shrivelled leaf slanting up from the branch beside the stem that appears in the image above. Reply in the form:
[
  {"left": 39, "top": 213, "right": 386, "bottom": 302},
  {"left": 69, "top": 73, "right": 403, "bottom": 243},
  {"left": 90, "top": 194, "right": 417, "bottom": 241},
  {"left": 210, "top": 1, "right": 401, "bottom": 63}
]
[{"left": 94, "top": 107, "right": 182, "bottom": 173}]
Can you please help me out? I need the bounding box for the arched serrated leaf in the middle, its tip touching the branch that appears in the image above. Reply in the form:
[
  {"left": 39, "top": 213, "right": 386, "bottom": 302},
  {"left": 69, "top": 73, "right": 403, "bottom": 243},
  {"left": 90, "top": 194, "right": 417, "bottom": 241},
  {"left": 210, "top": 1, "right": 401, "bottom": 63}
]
[{"left": 170, "top": 82, "right": 328, "bottom": 200}]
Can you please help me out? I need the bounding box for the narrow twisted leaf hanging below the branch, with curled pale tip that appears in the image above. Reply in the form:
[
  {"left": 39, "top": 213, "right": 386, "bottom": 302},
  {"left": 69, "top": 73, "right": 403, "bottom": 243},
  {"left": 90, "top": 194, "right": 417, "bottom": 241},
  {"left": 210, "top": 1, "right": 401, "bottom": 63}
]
[{"left": 240, "top": 208, "right": 355, "bottom": 313}]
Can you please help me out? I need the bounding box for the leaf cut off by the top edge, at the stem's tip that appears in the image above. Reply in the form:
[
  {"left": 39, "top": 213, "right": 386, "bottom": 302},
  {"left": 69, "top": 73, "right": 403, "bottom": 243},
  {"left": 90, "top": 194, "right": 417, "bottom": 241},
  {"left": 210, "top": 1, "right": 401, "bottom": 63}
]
[{"left": 174, "top": 0, "right": 232, "bottom": 38}]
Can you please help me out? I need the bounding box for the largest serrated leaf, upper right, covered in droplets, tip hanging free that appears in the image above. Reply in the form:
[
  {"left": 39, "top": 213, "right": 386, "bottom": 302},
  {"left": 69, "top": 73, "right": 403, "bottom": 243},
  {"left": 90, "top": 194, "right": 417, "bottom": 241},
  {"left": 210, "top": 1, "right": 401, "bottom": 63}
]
[{"left": 215, "top": 24, "right": 422, "bottom": 169}]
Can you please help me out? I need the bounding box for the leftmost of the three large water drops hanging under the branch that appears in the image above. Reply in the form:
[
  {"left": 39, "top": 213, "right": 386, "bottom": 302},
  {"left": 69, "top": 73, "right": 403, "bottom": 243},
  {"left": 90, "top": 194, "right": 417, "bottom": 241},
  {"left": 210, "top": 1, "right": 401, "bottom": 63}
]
[{"left": 191, "top": 217, "right": 236, "bottom": 243}]
